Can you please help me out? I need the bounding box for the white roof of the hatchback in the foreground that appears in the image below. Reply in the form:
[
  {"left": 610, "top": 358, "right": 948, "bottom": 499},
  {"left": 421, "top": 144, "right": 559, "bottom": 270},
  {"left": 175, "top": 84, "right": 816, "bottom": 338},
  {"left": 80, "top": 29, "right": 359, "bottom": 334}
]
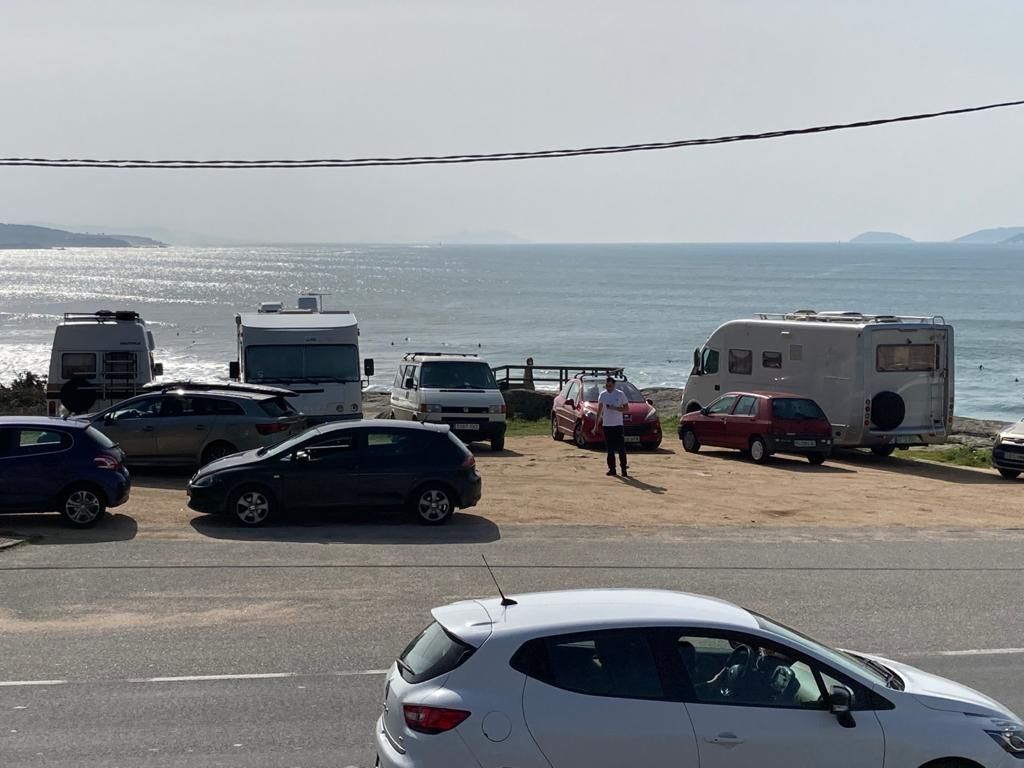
[{"left": 433, "top": 589, "right": 758, "bottom": 642}]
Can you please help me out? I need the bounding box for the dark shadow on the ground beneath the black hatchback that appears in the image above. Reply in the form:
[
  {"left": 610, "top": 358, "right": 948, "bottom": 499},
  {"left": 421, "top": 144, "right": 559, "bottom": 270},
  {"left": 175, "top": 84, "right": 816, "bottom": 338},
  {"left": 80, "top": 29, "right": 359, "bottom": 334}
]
[{"left": 190, "top": 510, "right": 502, "bottom": 544}]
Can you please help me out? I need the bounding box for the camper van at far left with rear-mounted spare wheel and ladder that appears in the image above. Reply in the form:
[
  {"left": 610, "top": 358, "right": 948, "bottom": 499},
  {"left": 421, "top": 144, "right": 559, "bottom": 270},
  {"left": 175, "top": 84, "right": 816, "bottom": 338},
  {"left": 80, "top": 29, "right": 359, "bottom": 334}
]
[{"left": 46, "top": 309, "right": 163, "bottom": 416}]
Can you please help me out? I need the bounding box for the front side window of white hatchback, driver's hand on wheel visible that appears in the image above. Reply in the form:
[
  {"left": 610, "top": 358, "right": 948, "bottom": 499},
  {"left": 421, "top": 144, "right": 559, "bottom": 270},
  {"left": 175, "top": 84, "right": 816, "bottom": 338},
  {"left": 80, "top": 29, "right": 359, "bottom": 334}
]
[{"left": 674, "top": 632, "right": 826, "bottom": 710}]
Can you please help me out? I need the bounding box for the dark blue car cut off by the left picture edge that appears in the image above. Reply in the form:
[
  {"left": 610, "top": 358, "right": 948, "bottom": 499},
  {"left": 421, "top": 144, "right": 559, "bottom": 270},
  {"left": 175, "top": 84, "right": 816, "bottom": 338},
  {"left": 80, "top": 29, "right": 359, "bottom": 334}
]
[{"left": 0, "top": 416, "right": 131, "bottom": 527}]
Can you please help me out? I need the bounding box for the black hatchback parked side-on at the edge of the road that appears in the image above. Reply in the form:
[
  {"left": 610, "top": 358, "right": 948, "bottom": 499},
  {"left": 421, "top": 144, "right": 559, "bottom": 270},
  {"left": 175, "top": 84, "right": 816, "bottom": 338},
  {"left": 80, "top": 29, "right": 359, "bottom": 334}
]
[{"left": 188, "top": 420, "right": 480, "bottom": 525}]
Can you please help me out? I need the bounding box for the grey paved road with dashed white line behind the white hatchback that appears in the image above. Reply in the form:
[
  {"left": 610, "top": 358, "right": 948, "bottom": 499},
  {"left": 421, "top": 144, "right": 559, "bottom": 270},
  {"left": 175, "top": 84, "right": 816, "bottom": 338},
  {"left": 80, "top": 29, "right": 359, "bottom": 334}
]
[{"left": 0, "top": 525, "right": 1024, "bottom": 768}]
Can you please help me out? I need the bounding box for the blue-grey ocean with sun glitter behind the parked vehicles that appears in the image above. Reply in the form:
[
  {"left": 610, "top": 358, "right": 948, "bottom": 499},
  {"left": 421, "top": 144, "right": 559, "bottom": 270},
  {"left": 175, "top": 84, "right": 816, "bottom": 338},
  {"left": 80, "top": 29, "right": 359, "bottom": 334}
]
[{"left": 0, "top": 244, "right": 1024, "bottom": 420}]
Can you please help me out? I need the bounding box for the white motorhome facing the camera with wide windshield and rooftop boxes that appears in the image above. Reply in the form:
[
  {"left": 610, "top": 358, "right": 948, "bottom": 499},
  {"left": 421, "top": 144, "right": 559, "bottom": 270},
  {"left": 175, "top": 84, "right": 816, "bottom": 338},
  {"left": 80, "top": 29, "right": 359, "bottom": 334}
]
[{"left": 229, "top": 295, "right": 374, "bottom": 424}]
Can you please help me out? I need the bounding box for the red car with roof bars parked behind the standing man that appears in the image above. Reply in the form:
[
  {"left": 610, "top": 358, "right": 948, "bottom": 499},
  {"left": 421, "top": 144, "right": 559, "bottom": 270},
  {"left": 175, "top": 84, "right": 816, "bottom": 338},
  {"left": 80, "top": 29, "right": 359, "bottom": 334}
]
[{"left": 551, "top": 376, "right": 662, "bottom": 450}]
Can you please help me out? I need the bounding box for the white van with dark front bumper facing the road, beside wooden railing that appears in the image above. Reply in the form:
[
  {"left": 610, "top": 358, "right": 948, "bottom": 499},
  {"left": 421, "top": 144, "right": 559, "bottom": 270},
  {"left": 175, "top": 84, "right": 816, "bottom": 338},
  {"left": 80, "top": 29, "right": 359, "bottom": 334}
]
[{"left": 388, "top": 352, "right": 506, "bottom": 451}]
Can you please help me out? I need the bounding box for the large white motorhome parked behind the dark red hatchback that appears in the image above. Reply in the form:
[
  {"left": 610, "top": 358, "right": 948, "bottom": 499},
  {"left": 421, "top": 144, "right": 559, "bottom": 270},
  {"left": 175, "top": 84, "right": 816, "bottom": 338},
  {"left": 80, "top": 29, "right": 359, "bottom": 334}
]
[{"left": 682, "top": 309, "right": 953, "bottom": 456}]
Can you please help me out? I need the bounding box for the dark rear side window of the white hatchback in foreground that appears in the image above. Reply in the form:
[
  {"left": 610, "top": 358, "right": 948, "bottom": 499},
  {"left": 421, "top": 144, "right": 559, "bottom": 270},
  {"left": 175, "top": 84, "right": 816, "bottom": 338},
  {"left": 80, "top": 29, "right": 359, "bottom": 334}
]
[{"left": 512, "top": 630, "right": 666, "bottom": 699}]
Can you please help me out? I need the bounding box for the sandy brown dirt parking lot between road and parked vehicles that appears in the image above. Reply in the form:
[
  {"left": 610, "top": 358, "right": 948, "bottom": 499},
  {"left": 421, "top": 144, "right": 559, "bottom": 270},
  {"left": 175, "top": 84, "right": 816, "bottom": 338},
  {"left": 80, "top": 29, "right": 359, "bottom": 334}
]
[{"left": 0, "top": 437, "right": 1024, "bottom": 542}]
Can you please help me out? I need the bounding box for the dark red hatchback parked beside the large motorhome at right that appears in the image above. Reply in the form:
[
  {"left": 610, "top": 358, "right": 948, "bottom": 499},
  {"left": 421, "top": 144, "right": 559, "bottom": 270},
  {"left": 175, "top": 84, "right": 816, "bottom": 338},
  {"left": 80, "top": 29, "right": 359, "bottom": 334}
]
[{"left": 679, "top": 392, "right": 833, "bottom": 464}]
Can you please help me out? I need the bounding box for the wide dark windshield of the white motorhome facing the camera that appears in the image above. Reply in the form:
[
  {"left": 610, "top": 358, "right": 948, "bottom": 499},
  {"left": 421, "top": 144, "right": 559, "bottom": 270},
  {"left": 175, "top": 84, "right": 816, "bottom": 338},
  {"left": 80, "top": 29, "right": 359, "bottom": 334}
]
[{"left": 246, "top": 344, "right": 359, "bottom": 382}]
